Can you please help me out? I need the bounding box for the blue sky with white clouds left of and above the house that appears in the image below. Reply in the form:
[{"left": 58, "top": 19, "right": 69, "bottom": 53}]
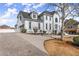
[{"left": 0, "top": 3, "right": 76, "bottom": 27}]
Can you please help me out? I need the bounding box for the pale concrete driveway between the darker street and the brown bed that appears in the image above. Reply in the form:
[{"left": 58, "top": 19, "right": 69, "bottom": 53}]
[{"left": 17, "top": 33, "right": 51, "bottom": 54}]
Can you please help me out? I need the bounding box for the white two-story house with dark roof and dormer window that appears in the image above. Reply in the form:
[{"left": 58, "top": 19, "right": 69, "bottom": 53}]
[{"left": 16, "top": 11, "right": 61, "bottom": 34}]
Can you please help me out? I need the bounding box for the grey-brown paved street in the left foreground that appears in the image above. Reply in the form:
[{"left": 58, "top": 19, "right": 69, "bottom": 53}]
[{"left": 0, "top": 33, "right": 47, "bottom": 56}]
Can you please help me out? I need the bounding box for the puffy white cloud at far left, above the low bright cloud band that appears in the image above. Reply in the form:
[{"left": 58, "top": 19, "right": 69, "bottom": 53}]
[{"left": 0, "top": 8, "right": 18, "bottom": 18}]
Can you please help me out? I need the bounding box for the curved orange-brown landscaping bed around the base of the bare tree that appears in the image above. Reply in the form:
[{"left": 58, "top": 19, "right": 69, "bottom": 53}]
[{"left": 44, "top": 37, "right": 79, "bottom": 56}]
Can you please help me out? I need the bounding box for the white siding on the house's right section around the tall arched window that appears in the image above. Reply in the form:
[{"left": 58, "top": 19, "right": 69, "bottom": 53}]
[{"left": 43, "top": 13, "right": 61, "bottom": 34}]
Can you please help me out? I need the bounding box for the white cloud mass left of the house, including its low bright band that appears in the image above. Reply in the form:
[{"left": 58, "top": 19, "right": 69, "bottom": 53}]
[{"left": 0, "top": 8, "right": 18, "bottom": 26}]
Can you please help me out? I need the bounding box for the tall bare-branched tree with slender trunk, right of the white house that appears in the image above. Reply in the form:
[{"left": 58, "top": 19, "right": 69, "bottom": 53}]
[{"left": 48, "top": 3, "right": 79, "bottom": 40}]
